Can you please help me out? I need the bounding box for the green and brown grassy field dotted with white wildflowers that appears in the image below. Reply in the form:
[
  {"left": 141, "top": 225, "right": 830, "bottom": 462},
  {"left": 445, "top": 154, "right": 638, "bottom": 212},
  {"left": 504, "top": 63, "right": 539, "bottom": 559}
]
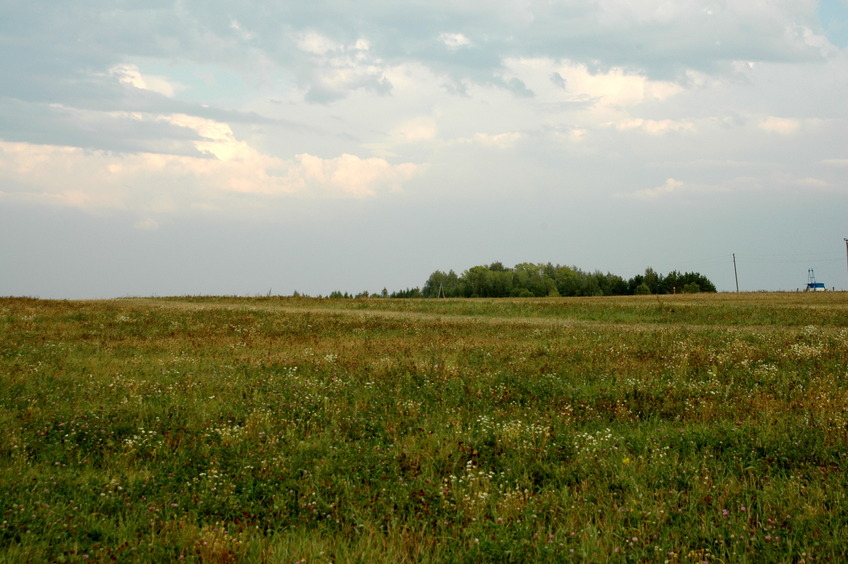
[{"left": 0, "top": 292, "right": 848, "bottom": 562}]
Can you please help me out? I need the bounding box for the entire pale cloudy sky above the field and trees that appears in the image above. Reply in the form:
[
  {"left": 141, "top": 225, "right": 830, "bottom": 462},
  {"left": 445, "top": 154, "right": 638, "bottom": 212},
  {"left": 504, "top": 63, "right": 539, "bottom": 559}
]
[{"left": 0, "top": 0, "right": 848, "bottom": 299}]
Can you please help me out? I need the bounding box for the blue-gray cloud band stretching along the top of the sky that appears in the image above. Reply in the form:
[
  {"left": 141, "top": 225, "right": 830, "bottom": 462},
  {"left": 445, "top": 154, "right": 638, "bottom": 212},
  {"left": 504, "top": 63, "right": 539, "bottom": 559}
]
[{"left": 0, "top": 1, "right": 836, "bottom": 112}]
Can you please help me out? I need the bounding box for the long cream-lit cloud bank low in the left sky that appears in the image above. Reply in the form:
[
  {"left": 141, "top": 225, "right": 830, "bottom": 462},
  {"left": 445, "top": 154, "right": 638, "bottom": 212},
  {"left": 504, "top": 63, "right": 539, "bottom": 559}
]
[{"left": 0, "top": 115, "right": 420, "bottom": 213}]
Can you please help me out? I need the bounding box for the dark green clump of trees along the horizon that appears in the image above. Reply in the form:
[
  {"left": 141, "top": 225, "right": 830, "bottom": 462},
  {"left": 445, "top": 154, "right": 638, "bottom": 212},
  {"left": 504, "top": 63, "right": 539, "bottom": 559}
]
[{"left": 322, "top": 262, "right": 716, "bottom": 298}]
